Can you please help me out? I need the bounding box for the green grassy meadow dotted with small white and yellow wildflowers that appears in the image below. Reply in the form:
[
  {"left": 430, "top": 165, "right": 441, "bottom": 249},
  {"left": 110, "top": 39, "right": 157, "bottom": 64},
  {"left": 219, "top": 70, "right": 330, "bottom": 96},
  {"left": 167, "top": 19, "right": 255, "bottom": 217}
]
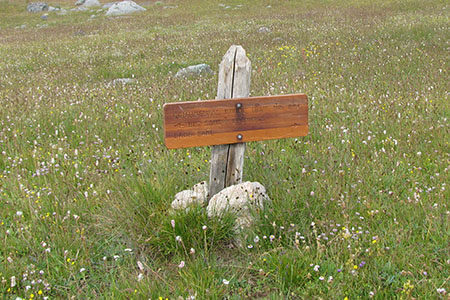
[{"left": 0, "top": 0, "right": 450, "bottom": 300}]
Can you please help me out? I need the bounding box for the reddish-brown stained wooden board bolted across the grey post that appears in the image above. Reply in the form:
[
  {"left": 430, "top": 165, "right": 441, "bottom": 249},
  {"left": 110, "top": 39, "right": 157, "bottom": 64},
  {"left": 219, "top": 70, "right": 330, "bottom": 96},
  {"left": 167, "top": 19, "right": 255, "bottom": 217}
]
[{"left": 164, "top": 94, "right": 308, "bottom": 149}]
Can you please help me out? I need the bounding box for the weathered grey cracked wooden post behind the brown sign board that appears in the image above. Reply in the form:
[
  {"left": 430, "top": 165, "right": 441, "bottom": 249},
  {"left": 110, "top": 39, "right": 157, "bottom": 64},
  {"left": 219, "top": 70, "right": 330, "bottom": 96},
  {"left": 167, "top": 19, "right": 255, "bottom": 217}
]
[{"left": 208, "top": 45, "right": 251, "bottom": 199}]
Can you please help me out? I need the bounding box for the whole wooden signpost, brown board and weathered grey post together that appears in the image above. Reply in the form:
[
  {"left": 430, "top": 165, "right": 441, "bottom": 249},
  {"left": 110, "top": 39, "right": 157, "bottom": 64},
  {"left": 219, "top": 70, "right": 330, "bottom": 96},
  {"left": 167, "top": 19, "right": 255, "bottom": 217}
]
[{"left": 164, "top": 46, "right": 308, "bottom": 198}]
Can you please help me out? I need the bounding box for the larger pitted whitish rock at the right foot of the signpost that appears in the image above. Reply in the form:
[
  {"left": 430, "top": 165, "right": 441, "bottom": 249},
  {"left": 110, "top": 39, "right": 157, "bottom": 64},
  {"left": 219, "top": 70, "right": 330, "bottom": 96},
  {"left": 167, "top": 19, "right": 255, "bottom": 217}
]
[{"left": 207, "top": 181, "right": 271, "bottom": 228}]
